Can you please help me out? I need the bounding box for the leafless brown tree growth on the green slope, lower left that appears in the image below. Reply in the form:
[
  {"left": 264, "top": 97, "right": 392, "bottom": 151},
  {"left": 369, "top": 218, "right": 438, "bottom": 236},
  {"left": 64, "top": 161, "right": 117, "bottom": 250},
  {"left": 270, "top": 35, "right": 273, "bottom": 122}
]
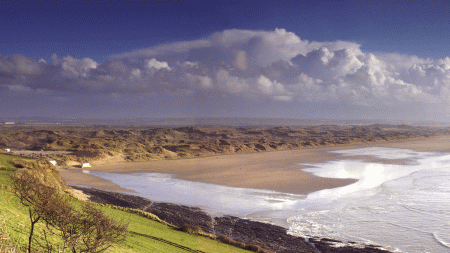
[{"left": 11, "top": 169, "right": 128, "bottom": 253}]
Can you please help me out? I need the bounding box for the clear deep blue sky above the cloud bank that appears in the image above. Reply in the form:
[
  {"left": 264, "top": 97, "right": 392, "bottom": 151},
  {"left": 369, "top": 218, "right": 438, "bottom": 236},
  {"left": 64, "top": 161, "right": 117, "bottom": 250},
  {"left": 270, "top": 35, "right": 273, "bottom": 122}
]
[{"left": 5, "top": 0, "right": 450, "bottom": 62}]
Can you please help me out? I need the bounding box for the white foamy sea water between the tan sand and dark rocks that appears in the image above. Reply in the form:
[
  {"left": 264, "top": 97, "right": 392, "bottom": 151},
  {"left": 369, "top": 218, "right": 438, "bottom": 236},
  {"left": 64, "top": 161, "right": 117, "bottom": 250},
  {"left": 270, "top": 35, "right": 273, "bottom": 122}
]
[{"left": 85, "top": 148, "right": 450, "bottom": 253}]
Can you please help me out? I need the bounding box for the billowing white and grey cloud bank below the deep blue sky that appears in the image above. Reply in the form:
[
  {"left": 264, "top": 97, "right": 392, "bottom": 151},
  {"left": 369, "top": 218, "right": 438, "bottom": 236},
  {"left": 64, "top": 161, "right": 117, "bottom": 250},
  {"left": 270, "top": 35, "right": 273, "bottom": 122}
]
[{"left": 0, "top": 29, "right": 450, "bottom": 119}]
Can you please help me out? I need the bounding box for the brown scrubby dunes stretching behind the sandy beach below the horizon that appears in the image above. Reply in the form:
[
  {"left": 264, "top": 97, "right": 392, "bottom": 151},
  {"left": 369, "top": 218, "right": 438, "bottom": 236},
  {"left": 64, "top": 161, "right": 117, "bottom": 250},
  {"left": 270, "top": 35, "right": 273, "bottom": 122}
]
[{"left": 0, "top": 125, "right": 450, "bottom": 164}]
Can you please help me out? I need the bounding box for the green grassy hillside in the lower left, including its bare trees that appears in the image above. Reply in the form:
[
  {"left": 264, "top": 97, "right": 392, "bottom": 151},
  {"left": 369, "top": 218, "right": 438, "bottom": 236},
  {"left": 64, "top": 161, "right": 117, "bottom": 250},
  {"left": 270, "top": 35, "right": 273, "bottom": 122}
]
[{"left": 0, "top": 154, "right": 266, "bottom": 253}]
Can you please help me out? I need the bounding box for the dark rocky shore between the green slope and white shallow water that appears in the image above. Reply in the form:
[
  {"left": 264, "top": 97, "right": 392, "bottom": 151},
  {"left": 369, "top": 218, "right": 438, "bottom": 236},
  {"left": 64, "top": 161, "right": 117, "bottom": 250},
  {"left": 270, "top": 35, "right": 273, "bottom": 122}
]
[{"left": 73, "top": 186, "right": 389, "bottom": 253}]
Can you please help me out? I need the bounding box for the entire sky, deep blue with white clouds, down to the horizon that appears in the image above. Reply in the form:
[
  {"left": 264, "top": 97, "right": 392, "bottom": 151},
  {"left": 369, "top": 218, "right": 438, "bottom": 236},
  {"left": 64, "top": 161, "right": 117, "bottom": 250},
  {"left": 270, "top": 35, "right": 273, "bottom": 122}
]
[{"left": 0, "top": 0, "right": 450, "bottom": 122}]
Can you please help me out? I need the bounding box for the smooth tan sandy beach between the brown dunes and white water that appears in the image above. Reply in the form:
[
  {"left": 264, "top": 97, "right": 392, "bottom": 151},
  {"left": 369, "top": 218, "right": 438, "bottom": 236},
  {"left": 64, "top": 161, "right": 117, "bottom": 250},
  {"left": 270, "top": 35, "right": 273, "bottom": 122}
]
[{"left": 60, "top": 136, "right": 450, "bottom": 194}]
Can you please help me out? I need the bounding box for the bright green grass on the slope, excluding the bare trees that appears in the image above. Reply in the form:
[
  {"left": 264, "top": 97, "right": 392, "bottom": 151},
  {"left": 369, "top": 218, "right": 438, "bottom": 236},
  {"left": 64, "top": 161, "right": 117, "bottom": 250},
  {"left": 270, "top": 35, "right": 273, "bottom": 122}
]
[{"left": 0, "top": 154, "right": 253, "bottom": 253}]
